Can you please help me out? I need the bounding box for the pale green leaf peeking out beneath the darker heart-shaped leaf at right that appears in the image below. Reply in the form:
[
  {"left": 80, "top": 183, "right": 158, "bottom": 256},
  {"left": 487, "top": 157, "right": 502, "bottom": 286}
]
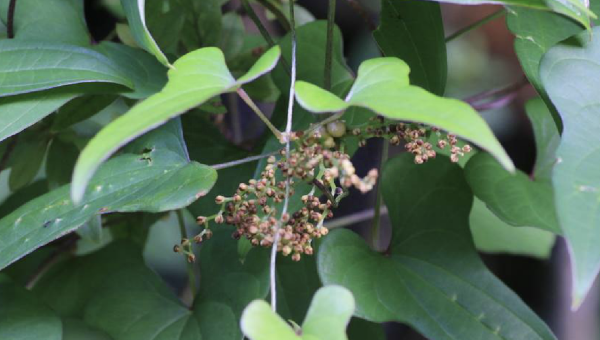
[{"left": 469, "top": 198, "right": 556, "bottom": 259}]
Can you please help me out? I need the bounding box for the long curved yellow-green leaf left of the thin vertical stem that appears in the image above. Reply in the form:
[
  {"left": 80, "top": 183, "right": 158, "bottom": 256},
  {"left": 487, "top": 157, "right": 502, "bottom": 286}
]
[{"left": 71, "top": 47, "right": 280, "bottom": 202}]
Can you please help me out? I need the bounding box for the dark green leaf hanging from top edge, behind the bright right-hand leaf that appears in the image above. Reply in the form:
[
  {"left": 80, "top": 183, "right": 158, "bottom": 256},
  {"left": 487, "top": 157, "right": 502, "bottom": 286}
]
[{"left": 373, "top": 0, "right": 448, "bottom": 96}]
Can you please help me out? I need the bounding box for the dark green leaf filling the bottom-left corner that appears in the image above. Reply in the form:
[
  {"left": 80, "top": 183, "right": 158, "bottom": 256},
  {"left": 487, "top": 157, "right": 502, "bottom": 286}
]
[{"left": 0, "top": 274, "right": 62, "bottom": 340}]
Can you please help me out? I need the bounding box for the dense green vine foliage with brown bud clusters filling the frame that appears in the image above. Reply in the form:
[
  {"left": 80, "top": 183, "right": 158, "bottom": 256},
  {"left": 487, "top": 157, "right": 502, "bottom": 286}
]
[{"left": 0, "top": 0, "right": 600, "bottom": 340}]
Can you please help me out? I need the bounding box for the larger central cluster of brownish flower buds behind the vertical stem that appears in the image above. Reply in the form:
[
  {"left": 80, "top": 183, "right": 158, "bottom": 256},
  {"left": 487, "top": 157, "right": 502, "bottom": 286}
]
[{"left": 196, "top": 124, "right": 378, "bottom": 261}]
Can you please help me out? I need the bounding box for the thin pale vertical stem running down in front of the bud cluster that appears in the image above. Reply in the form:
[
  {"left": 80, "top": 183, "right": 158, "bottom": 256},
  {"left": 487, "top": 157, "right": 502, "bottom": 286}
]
[{"left": 269, "top": 3, "right": 296, "bottom": 312}]
